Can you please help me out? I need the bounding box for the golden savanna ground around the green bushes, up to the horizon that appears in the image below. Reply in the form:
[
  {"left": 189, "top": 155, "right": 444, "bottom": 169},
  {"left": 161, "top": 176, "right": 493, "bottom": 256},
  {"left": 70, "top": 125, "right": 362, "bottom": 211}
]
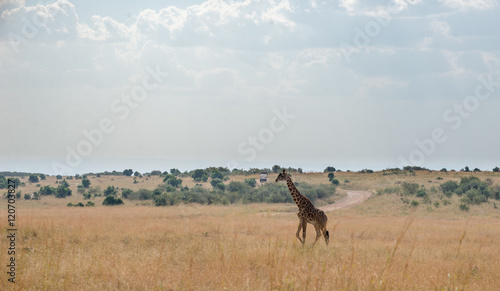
[{"left": 0, "top": 171, "right": 500, "bottom": 290}]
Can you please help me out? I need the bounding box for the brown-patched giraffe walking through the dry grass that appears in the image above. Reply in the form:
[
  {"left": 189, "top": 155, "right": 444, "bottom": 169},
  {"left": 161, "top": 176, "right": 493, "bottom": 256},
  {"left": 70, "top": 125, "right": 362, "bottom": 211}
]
[{"left": 276, "top": 170, "right": 330, "bottom": 245}]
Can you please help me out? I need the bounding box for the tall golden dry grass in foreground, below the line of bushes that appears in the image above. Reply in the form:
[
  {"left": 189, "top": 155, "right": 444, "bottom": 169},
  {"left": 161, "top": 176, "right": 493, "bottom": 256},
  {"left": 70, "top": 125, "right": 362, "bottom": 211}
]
[{"left": 0, "top": 204, "right": 500, "bottom": 290}]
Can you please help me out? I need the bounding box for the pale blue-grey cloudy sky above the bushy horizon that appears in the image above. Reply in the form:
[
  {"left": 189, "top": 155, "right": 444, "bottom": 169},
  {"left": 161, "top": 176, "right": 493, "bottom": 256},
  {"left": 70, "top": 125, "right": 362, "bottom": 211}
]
[{"left": 0, "top": 0, "right": 500, "bottom": 175}]
